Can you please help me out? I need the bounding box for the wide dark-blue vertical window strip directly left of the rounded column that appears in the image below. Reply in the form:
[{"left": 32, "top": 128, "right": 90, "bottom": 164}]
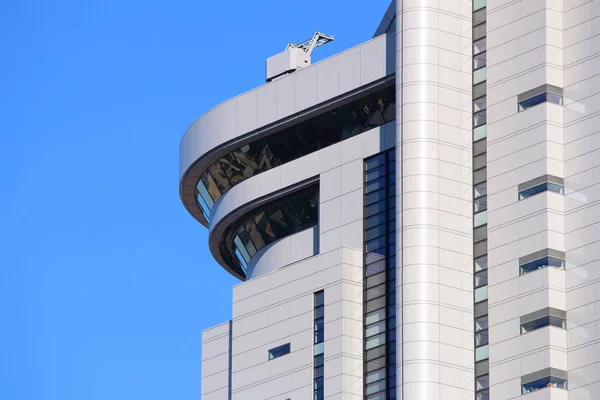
[{"left": 363, "top": 149, "right": 396, "bottom": 399}]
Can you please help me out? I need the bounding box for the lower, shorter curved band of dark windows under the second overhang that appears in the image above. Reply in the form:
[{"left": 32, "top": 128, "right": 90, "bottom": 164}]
[{"left": 232, "top": 185, "right": 319, "bottom": 273}]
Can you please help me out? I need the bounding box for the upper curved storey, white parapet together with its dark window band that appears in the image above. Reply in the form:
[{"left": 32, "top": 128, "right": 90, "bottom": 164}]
[{"left": 179, "top": 34, "right": 395, "bottom": 227}]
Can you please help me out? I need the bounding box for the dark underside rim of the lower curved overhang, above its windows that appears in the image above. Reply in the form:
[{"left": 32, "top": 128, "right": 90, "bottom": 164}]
[{"left": 208, "top": 176, "right": 319, "bottom": 281}]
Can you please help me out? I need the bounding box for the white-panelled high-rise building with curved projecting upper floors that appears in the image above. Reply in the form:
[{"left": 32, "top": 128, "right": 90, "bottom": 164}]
[{"left": 180, "top": 0, "right": 600, "bottom": 400}]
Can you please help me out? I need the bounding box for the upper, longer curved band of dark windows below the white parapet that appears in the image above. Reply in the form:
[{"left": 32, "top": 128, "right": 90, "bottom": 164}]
[{"left": 196, "top": 84, "right": 396, "bottom": 219}]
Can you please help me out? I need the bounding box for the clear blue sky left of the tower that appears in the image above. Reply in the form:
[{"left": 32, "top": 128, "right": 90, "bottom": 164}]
[{"left": 0, "top": 0, "right": 388, "bottom": 400}]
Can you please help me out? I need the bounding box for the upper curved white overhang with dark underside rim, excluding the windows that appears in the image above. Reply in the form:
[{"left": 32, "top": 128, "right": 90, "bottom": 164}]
[{"left": 180, "top": 34, "right": 395, "bottom": 227}]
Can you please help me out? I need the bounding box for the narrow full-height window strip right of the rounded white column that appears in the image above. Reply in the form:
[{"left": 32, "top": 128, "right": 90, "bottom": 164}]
[{"left": 472, "top": 4, "right": 489, "bottom": 400}]
